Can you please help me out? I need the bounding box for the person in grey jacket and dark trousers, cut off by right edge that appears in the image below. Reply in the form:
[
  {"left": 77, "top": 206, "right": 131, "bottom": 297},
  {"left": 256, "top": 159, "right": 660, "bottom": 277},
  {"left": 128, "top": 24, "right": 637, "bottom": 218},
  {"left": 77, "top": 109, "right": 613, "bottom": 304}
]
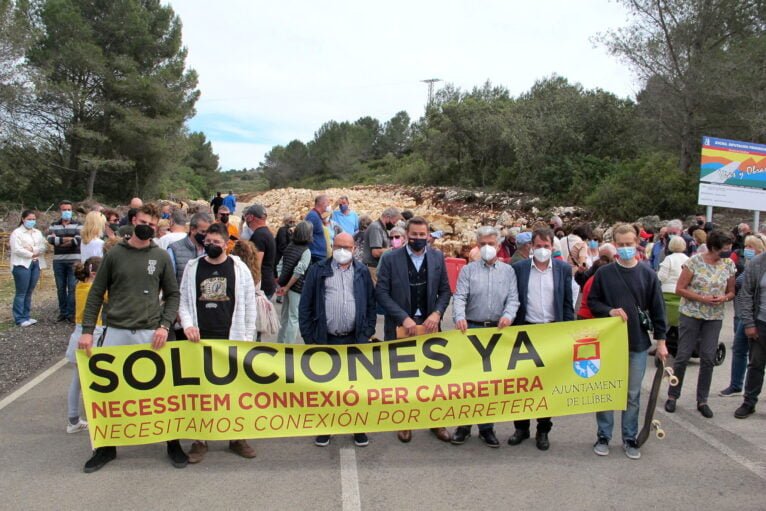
[{"left": 734, "top": 253, "right": 766, "bottom": 419}]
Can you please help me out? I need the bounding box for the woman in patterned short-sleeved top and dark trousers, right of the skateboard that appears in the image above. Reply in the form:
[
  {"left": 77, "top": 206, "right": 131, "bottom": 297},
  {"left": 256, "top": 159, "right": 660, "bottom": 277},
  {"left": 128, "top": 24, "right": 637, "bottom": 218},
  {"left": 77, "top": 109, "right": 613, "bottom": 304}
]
[{"left": 665, "top": 231, "right": 737, "bottom": 419}]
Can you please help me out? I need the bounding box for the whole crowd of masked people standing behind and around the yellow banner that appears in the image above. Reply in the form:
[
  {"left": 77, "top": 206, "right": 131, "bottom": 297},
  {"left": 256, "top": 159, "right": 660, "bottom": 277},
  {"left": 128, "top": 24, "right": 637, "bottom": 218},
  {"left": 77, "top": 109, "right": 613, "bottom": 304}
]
[{"left": 10, "top": 192, "right": 766, "bottom": 472}]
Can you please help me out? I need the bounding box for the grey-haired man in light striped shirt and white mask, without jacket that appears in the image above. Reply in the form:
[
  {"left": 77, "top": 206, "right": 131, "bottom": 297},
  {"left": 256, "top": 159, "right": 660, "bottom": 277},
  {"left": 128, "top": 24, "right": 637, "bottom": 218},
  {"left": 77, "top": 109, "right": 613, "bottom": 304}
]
[{"left": 452, "top": 227, "right": 519, "bottom": 447}]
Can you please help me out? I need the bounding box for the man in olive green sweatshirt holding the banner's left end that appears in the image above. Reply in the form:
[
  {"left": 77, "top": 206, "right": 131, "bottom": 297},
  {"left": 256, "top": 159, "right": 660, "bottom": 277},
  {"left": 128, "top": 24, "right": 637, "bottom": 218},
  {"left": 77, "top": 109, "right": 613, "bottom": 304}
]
[{"left": 78, "top": 205, "right": 188, "bottom": 473}]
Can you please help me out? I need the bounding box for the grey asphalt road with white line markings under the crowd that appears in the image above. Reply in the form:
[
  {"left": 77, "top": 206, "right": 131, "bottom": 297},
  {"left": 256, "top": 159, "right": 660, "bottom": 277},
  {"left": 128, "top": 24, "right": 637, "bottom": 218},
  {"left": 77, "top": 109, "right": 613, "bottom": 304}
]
[{"left": 0, "top": 306, "right": 766, "bottom": 511}]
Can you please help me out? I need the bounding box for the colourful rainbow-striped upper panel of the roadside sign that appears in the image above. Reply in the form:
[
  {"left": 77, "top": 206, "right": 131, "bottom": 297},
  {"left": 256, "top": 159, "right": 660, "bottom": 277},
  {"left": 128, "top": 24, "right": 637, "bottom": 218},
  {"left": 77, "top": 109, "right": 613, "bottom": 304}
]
[{"left": 700, "top": 137, "right": 766, "bottom": 189}]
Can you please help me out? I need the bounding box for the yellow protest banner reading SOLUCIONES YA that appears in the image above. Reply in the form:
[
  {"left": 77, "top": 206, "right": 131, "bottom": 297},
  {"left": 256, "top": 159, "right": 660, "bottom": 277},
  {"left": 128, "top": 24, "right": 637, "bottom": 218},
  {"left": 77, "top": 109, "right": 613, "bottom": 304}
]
[{"left": 77, "top": 318, "right": 628, "bottom": 447}]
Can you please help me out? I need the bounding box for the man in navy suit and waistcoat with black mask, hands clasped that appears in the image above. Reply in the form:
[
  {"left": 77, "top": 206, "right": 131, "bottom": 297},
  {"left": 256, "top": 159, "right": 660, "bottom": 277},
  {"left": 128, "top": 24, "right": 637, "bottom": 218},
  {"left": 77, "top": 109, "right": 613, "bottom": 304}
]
[{"left": 375, "top": 217, "right": 452, "bottom": 442}]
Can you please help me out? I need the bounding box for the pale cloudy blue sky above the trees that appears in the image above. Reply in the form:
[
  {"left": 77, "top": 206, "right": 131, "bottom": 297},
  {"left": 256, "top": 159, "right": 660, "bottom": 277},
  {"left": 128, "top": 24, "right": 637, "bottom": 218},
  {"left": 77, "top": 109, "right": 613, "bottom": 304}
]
[{"left": 169, "top": 0, "right": 639, "bottom": 170}]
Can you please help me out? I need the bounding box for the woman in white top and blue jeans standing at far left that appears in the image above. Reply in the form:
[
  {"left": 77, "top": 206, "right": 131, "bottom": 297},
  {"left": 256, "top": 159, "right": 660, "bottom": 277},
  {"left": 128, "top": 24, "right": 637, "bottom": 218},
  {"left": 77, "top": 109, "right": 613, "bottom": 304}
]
[{"left": 10, "top": 209, "right": 48, "bottom": 327}]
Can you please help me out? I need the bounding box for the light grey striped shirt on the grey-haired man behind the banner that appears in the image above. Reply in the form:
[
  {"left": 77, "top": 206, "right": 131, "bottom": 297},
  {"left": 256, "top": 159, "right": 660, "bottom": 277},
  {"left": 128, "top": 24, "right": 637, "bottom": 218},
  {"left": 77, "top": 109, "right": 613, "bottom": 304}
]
[{"left": 452, "top": 261, "right": 519, "bottom": 323}]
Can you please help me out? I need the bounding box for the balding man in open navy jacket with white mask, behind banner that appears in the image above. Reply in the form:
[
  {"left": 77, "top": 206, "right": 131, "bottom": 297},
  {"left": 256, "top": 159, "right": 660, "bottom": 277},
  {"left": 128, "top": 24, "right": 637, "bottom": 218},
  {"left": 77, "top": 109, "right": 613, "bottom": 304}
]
[{"left": 298, "top": 232, "right": 377, "bottom": 447}]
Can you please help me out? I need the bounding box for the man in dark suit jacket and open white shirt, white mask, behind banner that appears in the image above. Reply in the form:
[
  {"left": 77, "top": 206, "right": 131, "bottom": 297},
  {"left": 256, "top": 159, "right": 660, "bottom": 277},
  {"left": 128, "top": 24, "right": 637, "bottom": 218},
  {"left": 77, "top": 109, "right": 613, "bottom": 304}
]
[{"left": 508, "top": 229, "right": 574, "bottom": 451}]
